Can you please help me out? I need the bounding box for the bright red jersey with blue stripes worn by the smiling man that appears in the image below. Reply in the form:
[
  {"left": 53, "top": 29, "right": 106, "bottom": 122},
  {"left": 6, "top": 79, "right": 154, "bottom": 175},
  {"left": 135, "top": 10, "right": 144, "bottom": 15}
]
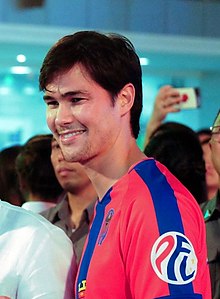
[{"left": 76, "top": 159, "right": 211, "bottom": 299}]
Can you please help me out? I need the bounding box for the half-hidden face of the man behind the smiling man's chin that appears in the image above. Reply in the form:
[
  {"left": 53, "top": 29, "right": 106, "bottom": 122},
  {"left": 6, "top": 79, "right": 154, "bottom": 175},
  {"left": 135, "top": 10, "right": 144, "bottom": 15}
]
[{"left": 51, "top": 140, "right": 91, "bottom": 193}]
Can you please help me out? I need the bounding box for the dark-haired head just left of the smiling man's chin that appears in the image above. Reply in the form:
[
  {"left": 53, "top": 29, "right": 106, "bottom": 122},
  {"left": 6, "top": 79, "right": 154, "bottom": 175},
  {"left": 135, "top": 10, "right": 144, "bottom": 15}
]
[{"left": 16, "top": 134, "right": 63, "bottom": 202}]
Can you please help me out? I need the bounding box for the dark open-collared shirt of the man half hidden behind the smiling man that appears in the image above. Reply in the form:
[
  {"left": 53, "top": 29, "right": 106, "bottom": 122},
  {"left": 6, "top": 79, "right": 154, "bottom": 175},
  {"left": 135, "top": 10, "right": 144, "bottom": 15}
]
[{"left": 41, "top": 195, "right": 95, "bottom": 264}]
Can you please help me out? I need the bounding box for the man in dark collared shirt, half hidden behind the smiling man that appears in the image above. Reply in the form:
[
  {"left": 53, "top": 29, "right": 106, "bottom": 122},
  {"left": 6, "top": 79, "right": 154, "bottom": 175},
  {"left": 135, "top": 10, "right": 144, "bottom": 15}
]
[{"left": 41, "top": 139, "right": 97, "bottom": 264}]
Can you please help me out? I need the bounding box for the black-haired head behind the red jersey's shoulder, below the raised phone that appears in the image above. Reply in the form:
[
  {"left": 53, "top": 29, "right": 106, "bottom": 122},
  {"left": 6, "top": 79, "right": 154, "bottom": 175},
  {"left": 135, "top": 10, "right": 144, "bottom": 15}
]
[{"left": 144, "top": 122, "right": 207, "bottom": 203}]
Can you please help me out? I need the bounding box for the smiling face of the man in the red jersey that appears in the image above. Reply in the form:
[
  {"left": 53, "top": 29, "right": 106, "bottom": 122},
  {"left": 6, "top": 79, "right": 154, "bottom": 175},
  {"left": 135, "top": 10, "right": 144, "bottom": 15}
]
[{"left": 44, "top": 65, "right": 121, "bottom": 164}]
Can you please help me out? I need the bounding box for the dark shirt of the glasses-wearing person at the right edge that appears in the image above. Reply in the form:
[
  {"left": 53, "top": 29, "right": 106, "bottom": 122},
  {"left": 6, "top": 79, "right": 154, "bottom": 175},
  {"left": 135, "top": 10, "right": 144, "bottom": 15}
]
[{"left": 201, "top": 190, "right": 220, "bottom": 299}]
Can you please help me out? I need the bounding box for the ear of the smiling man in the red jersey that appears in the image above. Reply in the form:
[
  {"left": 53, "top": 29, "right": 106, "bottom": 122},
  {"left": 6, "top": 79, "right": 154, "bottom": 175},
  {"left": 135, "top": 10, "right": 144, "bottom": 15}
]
[{"left": 117, "top": 83, "right": 135, "bottom": 115}]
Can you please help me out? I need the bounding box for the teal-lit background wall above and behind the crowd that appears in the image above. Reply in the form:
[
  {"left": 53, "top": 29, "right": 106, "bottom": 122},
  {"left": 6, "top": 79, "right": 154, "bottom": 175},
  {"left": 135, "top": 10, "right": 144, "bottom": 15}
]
[{"left": 0, "top": 0, "right": 220, "bottom": 149}]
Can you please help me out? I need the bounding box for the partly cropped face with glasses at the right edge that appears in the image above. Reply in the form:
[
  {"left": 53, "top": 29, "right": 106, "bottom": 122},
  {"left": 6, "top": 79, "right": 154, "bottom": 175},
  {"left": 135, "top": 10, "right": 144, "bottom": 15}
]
[{"left": 210, "top": 113, "right": 220, "bottom": 176}]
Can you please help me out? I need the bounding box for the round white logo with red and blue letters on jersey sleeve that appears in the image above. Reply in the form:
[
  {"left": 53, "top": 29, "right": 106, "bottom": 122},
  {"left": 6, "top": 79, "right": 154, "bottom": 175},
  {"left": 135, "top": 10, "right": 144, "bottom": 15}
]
[{"left": 151, "top": 232, "right": 197, "bottom": 285}]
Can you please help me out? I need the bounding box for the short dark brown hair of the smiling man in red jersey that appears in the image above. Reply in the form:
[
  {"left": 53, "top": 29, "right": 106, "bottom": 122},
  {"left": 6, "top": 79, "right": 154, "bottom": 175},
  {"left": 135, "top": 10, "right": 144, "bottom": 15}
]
[{"left": 39, "top": 31, "right": 142, "bottom": 138}]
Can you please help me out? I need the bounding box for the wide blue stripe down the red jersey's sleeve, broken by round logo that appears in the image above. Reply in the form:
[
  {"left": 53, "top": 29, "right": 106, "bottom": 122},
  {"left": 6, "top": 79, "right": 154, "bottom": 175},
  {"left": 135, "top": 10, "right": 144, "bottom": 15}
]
[{"left": 134, "top": 159, "right": 194, "bottom": 296}]
